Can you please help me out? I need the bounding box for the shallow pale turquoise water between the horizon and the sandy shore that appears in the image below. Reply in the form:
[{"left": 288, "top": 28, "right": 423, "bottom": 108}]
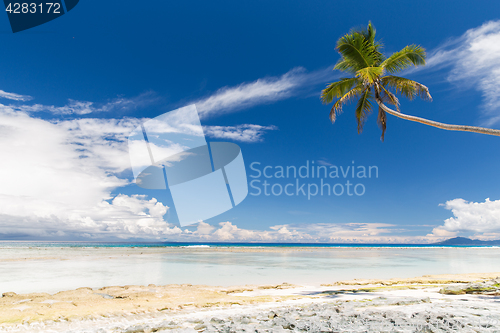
[{"left": 0, "top": 242, "right": 500, "bottom": 293}]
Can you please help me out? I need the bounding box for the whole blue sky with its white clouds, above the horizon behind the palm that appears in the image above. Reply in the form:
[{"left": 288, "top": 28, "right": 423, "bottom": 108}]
[{"left": 0, "top": 1, "right": 500, "bottom": 243}]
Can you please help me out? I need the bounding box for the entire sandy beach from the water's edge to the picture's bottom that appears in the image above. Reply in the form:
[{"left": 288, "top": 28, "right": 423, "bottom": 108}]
[{"left": 0, "top": 272, "right": 500, "bottom": 332}]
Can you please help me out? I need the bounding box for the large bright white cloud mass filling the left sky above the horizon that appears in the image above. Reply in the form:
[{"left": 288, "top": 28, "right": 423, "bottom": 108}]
[{"left": 0, "top": 106, "right": 182, "bottom": 238}]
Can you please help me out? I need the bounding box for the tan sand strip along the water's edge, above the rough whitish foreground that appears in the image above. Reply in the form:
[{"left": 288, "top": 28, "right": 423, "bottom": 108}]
[{"left": 0, "top": 272, "right": 500, "bottom": 329}]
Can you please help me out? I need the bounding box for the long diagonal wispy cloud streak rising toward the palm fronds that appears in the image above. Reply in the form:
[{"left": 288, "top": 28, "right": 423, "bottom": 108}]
[{"left": 195, "top": 67, "right": 336, "bottom": 117}]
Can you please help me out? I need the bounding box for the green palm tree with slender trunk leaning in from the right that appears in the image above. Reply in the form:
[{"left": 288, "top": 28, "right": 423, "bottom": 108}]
[{"left": 321, "top": 22, "right": 500, "bottom": 141}]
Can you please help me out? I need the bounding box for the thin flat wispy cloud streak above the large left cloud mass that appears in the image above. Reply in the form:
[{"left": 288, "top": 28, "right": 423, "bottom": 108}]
[{"left": 10, "top": 92, "right": 159, "bottom": 115}]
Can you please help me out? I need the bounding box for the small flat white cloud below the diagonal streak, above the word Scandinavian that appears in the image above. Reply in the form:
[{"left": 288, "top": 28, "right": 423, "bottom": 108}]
[{"left": 203, "top": 124, "right": 277, "bottom": 142}]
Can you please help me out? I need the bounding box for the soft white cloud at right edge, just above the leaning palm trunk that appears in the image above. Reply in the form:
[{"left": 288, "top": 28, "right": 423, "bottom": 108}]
[{"left": 425, "top": 21, "right": 500, "bottom": 126}]
